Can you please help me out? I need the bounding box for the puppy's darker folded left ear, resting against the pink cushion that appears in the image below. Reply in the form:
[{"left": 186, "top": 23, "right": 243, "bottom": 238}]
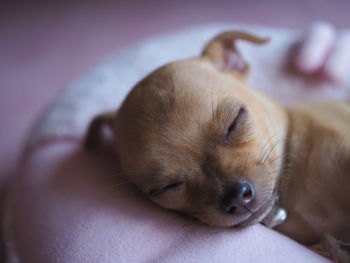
[{"left": 84, "top": 111, "right": 116, "bottom": 150}]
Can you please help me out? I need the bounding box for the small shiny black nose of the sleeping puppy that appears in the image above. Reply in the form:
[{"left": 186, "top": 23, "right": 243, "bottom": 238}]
[{"left": 221, "top": 180, "right": 255, "bottom": 214}]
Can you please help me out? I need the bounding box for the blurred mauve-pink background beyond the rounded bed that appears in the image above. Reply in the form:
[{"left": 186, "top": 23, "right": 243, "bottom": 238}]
[{"left": 0, "top": 0, "right": 350, "bottom": 252}]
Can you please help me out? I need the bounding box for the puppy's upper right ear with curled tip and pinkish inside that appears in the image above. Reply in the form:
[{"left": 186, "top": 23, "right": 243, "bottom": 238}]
[{"left": 202, "top": 31, "right": 269, "bottom": 76}]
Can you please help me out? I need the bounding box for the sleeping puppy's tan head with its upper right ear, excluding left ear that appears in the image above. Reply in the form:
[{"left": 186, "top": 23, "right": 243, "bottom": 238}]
[{"left": 113, "top": 32, "right": 285, "bottom": 226}]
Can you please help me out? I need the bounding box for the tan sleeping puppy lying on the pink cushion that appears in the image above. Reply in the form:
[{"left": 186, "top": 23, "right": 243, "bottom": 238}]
[{"left": 86, "top": 32, "right": 350, "bottom": 254}]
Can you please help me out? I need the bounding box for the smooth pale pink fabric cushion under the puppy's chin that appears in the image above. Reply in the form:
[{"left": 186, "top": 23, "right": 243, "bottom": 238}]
[{"left": 6, "top": 142, "right": 328, "bottom": 263}]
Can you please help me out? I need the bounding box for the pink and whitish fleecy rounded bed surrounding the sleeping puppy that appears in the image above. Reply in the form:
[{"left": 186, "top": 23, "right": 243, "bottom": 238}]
[{"left": 4, "top": 25, "right": 347, "bottom": 263}]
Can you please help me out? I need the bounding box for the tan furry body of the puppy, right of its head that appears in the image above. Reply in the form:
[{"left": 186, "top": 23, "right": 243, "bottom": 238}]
[{"left": 277, "top": 102, "right": 350, "bottom": 244}]
